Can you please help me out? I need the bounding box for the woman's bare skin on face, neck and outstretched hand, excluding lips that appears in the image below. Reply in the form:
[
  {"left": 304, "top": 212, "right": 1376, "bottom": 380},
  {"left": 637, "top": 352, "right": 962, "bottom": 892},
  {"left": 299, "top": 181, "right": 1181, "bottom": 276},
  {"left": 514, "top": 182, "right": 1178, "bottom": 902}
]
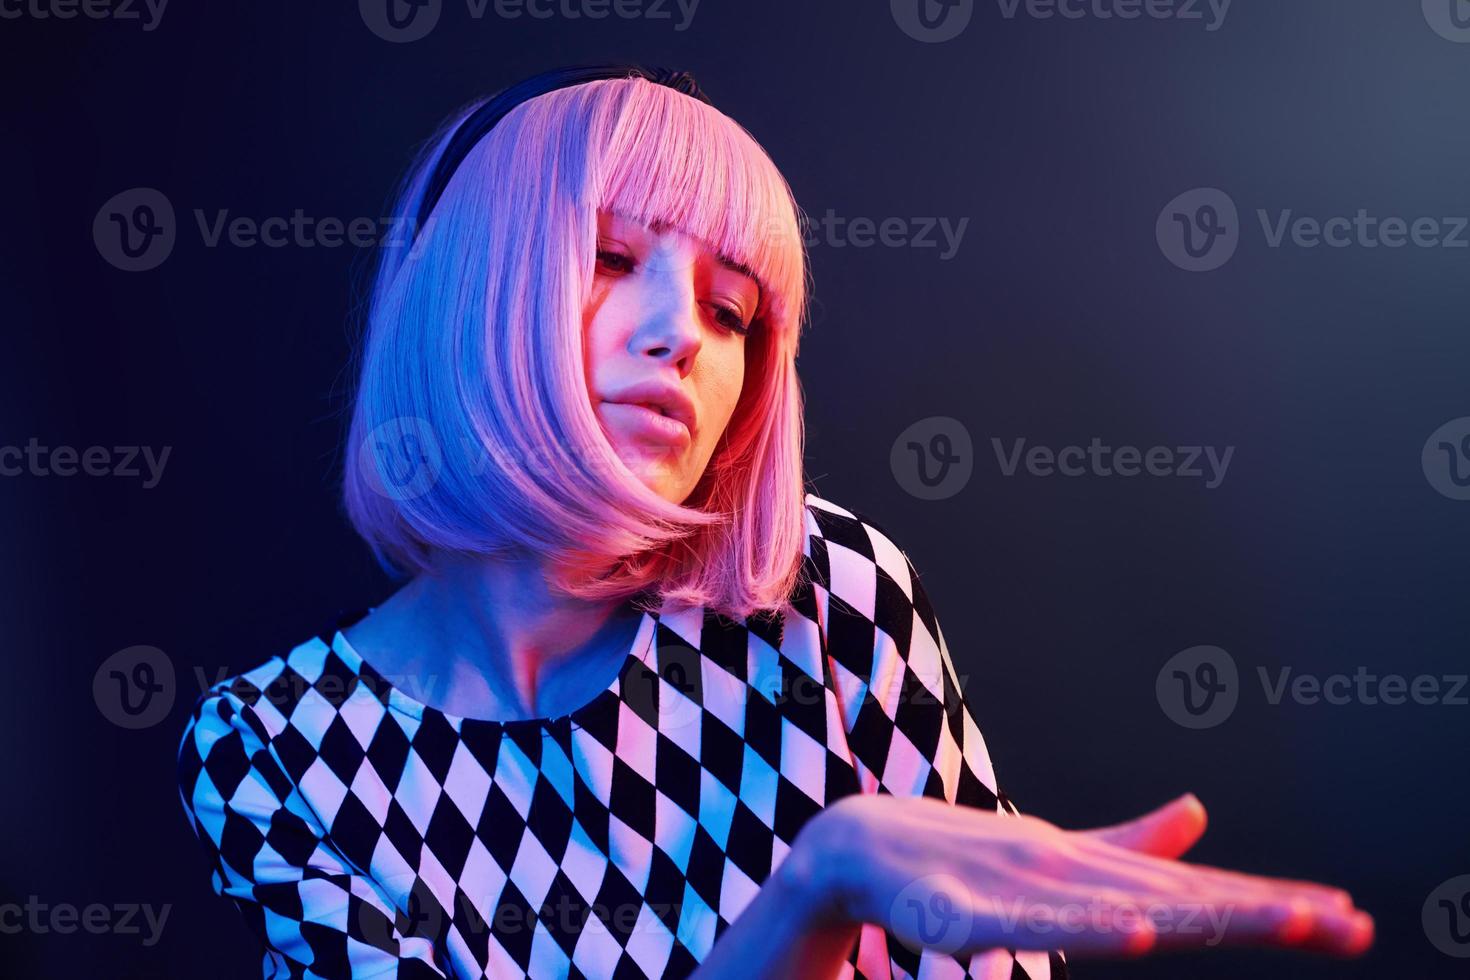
[{"left": 347, "top": 213, "right": 1373, "bottom": 980}]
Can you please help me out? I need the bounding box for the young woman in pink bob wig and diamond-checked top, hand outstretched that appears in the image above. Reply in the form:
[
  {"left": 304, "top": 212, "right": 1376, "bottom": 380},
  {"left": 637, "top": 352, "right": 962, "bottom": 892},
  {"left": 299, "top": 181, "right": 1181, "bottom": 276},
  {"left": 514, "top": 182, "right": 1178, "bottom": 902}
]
[{"left": 179, "top": 66, "right": 1372, "bottom": 980}]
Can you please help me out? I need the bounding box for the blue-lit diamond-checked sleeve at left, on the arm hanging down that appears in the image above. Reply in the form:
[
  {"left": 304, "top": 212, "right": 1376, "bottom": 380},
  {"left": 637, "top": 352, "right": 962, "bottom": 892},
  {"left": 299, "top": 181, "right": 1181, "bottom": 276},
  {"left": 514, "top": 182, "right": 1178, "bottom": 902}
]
[{"left": 178, "top": 682, "right": 448, "bottom": 980}]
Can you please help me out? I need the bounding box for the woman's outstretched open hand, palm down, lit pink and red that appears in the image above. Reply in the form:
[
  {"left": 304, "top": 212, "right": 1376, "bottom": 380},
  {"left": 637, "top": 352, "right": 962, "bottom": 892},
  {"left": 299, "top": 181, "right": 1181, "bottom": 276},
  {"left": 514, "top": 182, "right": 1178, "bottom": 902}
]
[{"left": 786, "top": 793, "right": 1373, "bottom": 956}]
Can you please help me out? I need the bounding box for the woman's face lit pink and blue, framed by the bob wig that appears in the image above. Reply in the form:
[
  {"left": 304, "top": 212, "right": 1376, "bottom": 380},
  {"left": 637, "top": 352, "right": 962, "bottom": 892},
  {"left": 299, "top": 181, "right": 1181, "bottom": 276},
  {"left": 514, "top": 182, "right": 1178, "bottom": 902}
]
[{"left": 582, "top": 213, "right": 760, "bottom": 504}]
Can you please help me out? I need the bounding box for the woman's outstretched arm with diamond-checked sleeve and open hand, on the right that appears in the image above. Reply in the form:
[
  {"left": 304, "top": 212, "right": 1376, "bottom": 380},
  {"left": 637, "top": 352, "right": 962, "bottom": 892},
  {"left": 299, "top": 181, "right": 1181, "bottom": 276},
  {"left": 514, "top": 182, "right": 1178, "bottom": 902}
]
[{"left": 694, "top": 502, "right": 1372, "bottom": 980}]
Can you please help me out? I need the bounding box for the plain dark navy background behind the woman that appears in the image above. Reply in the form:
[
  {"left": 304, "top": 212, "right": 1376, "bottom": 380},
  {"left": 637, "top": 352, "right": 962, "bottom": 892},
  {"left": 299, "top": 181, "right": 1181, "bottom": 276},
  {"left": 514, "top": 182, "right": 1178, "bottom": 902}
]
[{"left": 0, "top": 0, "right": 1470, "bottom": 980}]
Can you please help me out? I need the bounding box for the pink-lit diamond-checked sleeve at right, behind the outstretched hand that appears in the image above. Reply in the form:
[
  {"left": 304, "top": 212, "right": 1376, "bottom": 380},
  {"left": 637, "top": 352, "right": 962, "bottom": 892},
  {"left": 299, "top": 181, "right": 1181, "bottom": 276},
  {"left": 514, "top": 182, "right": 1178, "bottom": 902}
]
[{"left": 810, "top": 504, "right": 1067, "bottom": 980}]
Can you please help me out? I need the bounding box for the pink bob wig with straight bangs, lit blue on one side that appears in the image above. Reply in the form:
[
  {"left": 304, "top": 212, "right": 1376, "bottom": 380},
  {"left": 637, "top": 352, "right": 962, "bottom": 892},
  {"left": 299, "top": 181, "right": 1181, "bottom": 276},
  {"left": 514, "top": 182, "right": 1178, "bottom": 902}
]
[{"left": 343, "top": 76, "right": 809, "bottom": 619}]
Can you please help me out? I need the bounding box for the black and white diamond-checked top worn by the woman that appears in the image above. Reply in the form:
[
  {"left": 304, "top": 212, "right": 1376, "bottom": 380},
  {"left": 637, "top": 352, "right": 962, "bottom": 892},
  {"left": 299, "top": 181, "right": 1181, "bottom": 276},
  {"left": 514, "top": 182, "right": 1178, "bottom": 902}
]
[{"left": 179, "top": 494, "right": 1066, "bottom": 980}]
